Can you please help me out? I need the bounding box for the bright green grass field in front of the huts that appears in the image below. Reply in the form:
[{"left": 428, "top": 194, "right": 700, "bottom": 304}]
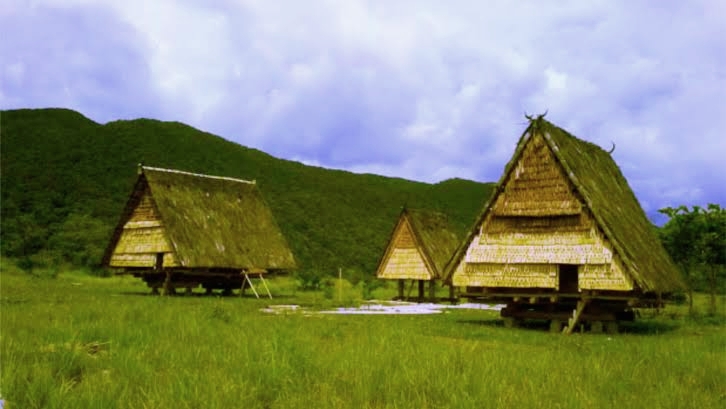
[{"left": 0, "top": 268, "right": 726, "bottom": 409}]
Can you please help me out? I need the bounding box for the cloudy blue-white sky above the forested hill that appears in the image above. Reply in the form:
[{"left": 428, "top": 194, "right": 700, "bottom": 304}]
[{"left": 0, "top": 0, "right": 726, "bottom": 222}]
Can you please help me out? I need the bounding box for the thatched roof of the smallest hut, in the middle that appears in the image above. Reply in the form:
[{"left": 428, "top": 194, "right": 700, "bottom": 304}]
[{"left": 377, "top": 208, "right": 459, "bottom": 278}]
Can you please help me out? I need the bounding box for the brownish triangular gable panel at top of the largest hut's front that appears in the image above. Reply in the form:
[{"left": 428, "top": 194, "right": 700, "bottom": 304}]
[{"left": 492, "top": 134, "right": 582, "bottom": 216}]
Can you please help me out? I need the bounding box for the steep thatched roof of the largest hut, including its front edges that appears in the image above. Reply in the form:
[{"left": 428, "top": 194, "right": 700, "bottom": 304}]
[{"left": 446, "top": 115, "right": 684, "bottom": 293}]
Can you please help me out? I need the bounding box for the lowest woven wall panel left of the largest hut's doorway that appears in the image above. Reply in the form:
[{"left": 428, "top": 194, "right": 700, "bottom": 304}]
[{"left": 454, "top": 263, "right": 558, "bottom": 288}]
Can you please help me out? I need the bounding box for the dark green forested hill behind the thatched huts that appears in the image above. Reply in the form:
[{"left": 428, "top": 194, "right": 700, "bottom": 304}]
[{"left": 0, "top": 109, "right": 493, "bottom": 273}]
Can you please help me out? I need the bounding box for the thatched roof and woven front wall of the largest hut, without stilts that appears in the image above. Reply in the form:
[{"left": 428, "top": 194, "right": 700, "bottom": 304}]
[{"left": 447, "top": 117, "right": 683, "bottom": 293}]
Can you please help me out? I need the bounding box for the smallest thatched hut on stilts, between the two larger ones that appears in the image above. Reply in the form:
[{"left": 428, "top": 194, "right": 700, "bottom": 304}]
[{"left": 376, "top": 208, "right": 459, "bottom": 299}]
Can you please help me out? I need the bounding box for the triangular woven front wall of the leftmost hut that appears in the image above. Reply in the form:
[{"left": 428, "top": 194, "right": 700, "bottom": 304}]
[{"left": 109, "top": 192, "right": 179, "bottom": 267}]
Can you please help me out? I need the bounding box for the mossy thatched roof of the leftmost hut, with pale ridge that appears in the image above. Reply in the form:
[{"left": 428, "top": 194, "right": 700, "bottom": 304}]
[{"left": 104, "top": 166, "right": 295, "bottom": 270}]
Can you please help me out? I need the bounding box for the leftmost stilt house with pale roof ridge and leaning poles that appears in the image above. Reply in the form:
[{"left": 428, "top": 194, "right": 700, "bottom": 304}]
[{"left": 103, "top": 165, "right": 295, "bottom": 294}]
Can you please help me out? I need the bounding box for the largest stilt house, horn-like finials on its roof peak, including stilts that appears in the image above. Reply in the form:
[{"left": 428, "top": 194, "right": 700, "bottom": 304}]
[{"left": 447, "top": 116, "right": 684, "bottom": 332}]
